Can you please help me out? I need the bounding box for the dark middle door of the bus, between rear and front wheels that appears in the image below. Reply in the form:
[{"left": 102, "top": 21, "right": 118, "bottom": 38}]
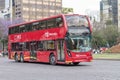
[{"left": 30, "top": 42, "right": 37, "bottom": 60}]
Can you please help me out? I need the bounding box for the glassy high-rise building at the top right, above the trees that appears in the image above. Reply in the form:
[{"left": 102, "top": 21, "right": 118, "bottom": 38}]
[{"left": 100, "top": 0, "right": 120, "bottom": 26}]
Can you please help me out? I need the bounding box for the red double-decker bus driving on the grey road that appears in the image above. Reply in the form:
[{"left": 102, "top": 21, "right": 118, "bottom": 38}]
[{"left": 8, "top": 14, "right": 92, "bottom": 65}]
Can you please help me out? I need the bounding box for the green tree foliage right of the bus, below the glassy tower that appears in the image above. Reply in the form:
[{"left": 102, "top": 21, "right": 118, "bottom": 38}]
[{"left": 92, "top": 23, "right": 119, "bottom": 48}]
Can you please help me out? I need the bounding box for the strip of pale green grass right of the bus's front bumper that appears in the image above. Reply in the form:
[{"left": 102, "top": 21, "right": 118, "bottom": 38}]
[{"left": 93, "top": 53, "right": 120, "bottom": 59}]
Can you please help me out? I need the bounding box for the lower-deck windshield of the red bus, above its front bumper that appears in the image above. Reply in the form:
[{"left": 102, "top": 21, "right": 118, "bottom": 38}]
[{"left": 66, "top": 36, "right": 91, "bottom": 52}]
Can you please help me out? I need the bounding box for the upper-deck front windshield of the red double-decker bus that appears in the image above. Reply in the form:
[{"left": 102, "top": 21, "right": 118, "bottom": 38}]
[{"left": 66, "top": 15, "right": 89, "bottom": 27}]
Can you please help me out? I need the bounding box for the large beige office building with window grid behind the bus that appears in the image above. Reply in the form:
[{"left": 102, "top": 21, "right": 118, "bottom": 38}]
[{"left": 10, "top": 0, "right": 62, "bottom": 21}]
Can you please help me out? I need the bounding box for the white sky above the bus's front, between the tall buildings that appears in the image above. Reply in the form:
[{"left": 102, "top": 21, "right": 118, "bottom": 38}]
[{"left": 62, "top": 0, "right": 101, "bottom": 14}]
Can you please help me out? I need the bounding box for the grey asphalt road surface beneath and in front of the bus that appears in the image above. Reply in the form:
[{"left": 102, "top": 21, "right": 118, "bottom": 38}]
[{"left": 0, "top": 57, "right": 120, "bottom": 80}]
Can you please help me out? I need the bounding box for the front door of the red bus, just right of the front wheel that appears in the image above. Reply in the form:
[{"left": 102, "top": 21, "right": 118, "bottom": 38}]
[{"left": 57, "top": 40, "right": 65, "bottom": 61}]
